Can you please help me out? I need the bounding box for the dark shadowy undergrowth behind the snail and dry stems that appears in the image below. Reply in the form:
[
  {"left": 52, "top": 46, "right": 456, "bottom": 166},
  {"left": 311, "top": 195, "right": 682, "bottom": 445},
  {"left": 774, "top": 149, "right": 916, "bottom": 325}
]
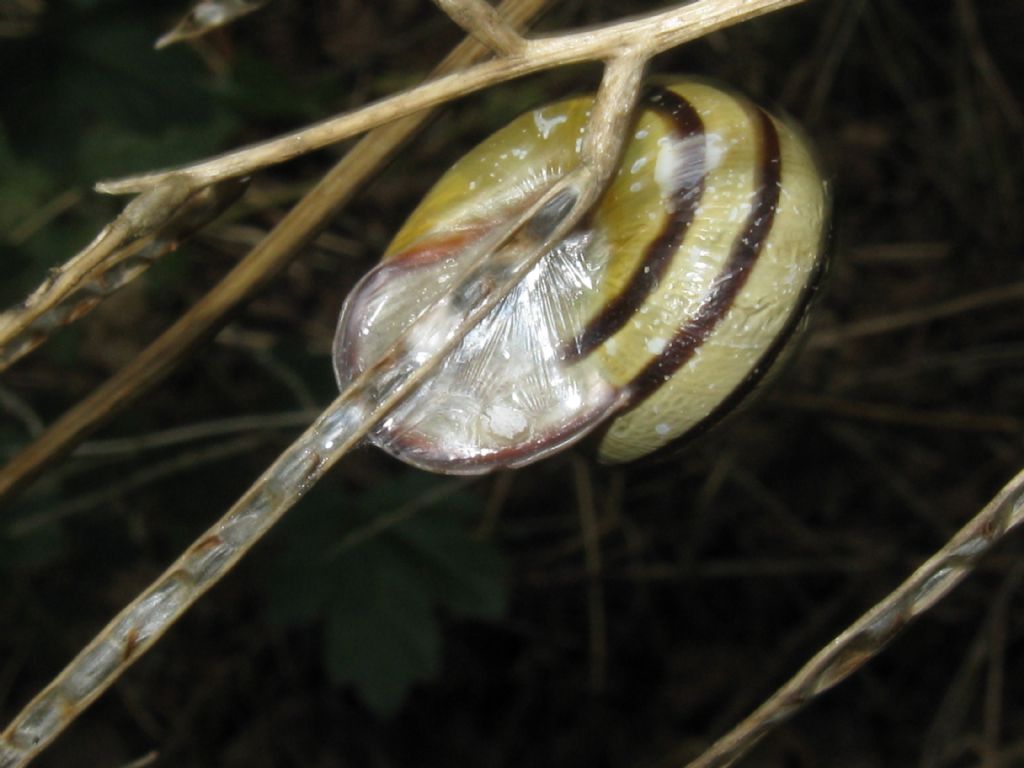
[{"left": 0, "top": 0, "right": 1024, "bottom": 768}]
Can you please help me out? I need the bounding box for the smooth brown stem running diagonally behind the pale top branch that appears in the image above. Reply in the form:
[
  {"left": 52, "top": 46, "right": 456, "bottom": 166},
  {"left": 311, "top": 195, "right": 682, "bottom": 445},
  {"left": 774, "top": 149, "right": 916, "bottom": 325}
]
[{"left": 0, "top": 0, "right": 547, "bottom": 504}]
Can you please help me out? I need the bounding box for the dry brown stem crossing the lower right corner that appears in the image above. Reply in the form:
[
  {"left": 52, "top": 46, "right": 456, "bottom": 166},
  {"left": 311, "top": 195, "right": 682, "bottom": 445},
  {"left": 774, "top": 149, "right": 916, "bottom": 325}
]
[{"left": 686, "top": 471, "right": 1024, "bottom": 768}]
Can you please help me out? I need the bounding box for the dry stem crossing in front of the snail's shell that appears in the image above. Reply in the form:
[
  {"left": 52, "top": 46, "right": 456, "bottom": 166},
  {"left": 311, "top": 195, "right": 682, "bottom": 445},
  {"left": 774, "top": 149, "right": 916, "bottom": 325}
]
[{"left": 0, "top": 56, "right": 644, "bottom": 768}]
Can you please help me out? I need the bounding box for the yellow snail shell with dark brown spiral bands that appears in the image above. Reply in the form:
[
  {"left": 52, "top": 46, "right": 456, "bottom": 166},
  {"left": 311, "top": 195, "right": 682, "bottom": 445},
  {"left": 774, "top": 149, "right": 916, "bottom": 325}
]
[{"left": 335, "top": 79, "right": 828, "bottom": 473}]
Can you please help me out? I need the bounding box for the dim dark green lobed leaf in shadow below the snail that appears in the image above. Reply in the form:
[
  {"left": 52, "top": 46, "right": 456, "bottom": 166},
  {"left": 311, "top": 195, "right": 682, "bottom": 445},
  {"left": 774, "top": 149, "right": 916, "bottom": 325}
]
[{"left": 268, "top": 471, "right": 507, "bottom": 717}]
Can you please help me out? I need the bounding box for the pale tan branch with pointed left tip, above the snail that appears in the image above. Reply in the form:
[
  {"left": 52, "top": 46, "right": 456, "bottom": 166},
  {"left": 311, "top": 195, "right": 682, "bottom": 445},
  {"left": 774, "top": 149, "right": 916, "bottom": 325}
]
[{"left": 96, "top": 0, "right": 805, "bottom": 195}]
